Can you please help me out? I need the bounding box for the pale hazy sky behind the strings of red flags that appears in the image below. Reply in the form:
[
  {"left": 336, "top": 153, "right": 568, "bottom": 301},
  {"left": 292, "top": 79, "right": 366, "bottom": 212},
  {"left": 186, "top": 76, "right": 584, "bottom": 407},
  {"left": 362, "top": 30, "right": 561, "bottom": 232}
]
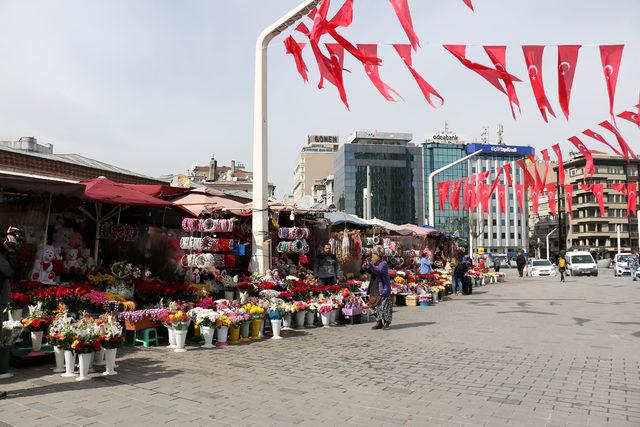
[{"left": 0, "top": 0, "right": 640, "bottom": 196}]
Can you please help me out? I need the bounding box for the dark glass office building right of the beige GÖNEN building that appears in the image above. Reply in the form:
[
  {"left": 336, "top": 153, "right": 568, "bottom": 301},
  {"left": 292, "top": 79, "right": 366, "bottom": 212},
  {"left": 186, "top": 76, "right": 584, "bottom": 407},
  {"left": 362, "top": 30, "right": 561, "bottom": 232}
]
[{"left": 334, "top": 131, "right": 424, "bottom": 224}]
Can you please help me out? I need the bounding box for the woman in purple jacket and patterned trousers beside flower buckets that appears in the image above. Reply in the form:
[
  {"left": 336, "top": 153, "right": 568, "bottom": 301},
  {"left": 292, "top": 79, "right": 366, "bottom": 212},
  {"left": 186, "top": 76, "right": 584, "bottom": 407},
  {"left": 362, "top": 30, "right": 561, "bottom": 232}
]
[{"left": 362, "top": 247, "right": 393, "bottom": 329}]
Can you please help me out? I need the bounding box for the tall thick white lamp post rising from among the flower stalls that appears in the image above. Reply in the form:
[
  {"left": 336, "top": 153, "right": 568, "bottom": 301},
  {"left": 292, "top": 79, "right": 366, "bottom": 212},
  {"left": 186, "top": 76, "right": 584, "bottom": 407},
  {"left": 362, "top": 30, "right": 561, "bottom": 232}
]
[{"left": 251, "top": 0, "right": 320, "bottom": 273}]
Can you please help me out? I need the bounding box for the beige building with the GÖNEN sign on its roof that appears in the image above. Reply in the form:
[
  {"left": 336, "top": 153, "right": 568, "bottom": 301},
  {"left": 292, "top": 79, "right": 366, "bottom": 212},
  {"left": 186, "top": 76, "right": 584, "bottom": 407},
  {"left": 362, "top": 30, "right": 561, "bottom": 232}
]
[{"left": 293, "top": 135, "right": 340, "bottom": 201}]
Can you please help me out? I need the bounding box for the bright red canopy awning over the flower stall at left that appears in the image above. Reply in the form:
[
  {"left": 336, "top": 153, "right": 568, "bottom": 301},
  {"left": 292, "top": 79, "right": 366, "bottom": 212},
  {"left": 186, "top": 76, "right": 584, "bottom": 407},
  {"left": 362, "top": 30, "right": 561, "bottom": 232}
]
[{"left": 84, "top": 177, "right": 171, "bottom": 206}]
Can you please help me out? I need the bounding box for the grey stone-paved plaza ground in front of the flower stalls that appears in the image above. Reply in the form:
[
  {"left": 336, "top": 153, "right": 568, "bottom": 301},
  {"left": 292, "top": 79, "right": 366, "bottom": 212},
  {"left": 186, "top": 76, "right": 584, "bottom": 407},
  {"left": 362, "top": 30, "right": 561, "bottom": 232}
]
[{"left": 0, "top": 270, "right": 640, "bottom": 426}]
